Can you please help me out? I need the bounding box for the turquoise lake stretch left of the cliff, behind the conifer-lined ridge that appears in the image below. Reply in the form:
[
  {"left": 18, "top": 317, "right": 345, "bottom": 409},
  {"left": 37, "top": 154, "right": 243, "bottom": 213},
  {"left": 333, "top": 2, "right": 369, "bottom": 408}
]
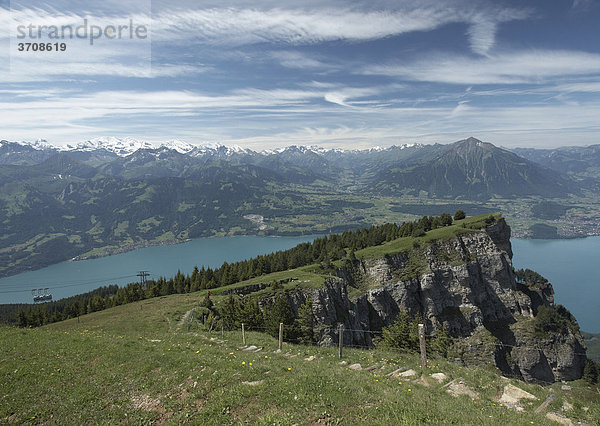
[{"left": 0, "top": 235, "right": 316, "bottom": 304}]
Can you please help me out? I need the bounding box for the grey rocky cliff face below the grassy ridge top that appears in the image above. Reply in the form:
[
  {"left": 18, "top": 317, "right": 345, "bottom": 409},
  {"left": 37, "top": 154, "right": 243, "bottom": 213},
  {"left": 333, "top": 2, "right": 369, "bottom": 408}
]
[{"left": 288, "top": 219, "right": 585, "bottom": 382}]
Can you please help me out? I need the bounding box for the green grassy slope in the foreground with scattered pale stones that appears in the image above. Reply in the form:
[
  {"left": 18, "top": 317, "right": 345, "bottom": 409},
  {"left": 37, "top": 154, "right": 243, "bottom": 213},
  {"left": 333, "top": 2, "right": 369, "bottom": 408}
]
[{"left": 0, "top": 293, "right": 600, "bottom": 425}]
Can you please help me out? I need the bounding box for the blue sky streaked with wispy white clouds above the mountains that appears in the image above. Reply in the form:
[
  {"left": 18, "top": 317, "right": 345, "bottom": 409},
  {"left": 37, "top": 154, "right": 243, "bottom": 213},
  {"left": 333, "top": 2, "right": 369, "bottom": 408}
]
[{"left": 0, "top": 0, "right": 600, "bottom": 149}]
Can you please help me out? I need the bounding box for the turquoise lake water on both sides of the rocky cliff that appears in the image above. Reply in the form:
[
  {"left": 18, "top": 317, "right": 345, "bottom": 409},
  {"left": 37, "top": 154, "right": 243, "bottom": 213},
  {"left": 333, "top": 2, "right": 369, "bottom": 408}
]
[{"left": 0, "top": 236, "right": 600, "bottom": 333}]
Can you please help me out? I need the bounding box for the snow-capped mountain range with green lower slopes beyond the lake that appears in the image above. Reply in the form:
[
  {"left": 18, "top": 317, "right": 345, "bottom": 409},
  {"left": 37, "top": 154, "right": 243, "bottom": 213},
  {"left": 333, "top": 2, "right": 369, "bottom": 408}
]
[{"left": 0, "top": 138, "right": 600, "bottom": 275}]
